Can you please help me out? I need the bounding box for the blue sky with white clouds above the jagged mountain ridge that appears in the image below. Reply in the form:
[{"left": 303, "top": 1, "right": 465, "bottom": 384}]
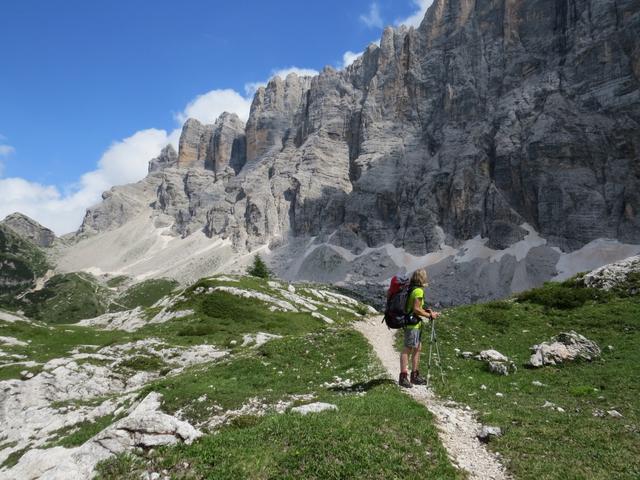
[{"left": 0, "top": 0, "right": 431, "bottom": 233}]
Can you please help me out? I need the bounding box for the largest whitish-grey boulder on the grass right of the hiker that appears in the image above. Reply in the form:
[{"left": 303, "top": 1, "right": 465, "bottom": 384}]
[{"left": 528, "top": 331, "right": 601, "bottom": 368}]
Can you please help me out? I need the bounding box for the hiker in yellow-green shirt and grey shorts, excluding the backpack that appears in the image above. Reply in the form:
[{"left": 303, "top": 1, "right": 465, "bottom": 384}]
[{"left": 398, "top": 269, "right": 440, "bottom": 388}]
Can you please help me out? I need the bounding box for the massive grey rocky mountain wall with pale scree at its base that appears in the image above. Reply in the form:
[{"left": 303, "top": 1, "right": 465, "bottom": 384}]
[{"left": 60, "top": 0, "right": 640, "bottom": 303}]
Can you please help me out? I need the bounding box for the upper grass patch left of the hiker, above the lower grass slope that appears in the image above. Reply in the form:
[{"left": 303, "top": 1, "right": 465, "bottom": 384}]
[{"left": 136, "top": 328, "right": 377, "bottom": 423}]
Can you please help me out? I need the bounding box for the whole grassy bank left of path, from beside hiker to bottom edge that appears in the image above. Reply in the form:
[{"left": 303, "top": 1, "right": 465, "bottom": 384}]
[{"left": 98, "top": 326, "right": 463, "bottom": 479}]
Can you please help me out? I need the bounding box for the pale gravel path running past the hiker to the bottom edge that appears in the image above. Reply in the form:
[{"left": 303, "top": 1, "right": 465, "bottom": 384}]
[{"left": 355, "top": 317, "right": 511, "bottom": 480}]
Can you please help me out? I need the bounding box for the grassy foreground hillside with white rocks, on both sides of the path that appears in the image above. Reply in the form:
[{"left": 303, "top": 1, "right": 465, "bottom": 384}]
[{"left": 0, "top": 261, "right": 640, "bottom": 479}]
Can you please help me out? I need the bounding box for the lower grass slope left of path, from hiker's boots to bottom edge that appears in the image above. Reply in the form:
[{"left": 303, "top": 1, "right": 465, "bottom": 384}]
[{"left": 98, "top": 383, "right": 463, "bottom": 480}]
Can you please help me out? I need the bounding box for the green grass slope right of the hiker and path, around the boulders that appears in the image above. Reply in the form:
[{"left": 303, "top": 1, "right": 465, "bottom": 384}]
[{"left": 422, "top": 283, "right": 640, "bottom": 479}]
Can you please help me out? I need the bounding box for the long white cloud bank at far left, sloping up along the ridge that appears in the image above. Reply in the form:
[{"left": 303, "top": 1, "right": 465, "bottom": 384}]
[{"left": 0, "top": 129, "right": 169, "bottom": 234}]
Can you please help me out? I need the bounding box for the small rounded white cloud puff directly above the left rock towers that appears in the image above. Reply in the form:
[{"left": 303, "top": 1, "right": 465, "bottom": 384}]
[{"left": 176, "top": 89, "right": 251, "bottom": 124}]
